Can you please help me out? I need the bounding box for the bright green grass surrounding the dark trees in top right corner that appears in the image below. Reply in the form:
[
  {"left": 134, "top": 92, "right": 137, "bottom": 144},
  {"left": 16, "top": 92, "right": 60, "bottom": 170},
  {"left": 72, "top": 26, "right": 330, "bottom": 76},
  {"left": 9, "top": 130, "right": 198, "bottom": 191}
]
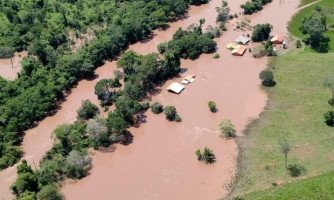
[{"left": 288, "top": 0, "right": 334, "bottom": 52}]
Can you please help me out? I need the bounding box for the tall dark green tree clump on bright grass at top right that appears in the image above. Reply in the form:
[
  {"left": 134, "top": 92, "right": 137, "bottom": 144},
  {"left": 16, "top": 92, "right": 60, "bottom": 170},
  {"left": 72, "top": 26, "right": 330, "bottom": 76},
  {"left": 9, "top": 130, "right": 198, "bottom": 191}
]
[{"left": 300, "top": 6, "right": 329, "bottom": 53}]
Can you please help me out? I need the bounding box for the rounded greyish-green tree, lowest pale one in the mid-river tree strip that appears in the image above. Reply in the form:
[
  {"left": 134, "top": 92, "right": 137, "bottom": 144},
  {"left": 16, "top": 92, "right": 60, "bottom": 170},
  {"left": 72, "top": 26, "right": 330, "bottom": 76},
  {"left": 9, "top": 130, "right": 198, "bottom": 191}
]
[{"left": 64, "top": 150, "right": 92, "bottom": 179}]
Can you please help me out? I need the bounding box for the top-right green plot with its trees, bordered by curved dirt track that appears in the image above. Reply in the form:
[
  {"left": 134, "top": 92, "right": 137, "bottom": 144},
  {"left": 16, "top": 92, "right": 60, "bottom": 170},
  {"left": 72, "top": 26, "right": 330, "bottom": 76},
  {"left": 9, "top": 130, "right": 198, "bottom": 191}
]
[{"left": 289, "top": 0, "right": 334, "bottom": 52}]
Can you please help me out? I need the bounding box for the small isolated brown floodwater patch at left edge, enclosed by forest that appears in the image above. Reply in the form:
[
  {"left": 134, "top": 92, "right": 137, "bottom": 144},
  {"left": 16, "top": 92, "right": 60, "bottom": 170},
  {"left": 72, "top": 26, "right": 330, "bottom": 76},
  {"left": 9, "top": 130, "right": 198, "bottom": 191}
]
[{"left": 0, "top": 51, "right": 27, "bottom": 80}]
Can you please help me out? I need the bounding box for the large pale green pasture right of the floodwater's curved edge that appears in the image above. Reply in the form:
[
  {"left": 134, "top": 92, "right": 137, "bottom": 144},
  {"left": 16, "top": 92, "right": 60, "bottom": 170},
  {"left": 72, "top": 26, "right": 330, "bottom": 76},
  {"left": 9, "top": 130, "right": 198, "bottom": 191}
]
[{"left": 234, "top": 51, "right": 334, "bottom": 194}]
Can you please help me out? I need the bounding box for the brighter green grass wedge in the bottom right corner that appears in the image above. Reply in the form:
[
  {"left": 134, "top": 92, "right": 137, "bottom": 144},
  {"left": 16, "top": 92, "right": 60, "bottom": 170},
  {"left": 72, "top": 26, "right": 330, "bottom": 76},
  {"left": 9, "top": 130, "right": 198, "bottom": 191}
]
[{"left": 244, "top": 172, "right": 334, "bottom": 200}]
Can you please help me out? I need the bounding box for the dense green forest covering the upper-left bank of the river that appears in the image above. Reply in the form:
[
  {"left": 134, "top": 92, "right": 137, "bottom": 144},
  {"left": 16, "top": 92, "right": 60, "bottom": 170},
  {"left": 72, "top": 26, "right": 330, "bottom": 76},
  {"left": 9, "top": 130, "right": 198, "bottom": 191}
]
[{"left": 0, "top": 0, "right": 213, "bottom": 169}]
